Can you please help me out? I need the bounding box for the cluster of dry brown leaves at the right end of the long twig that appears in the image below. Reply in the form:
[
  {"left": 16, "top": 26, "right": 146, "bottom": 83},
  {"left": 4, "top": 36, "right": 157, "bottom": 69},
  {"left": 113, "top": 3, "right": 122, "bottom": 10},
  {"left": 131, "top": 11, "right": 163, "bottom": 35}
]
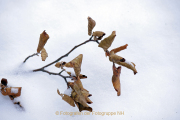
[{"left": 88, "top": 17, "right": 137, "bottom": 96}]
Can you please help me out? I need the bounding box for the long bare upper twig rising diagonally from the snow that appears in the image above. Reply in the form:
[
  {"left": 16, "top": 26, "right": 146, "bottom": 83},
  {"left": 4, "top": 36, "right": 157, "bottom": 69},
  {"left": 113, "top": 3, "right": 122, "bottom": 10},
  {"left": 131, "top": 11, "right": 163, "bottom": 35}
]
[{"left": 33, "top": 36, "right": 96, "bottom": 72}]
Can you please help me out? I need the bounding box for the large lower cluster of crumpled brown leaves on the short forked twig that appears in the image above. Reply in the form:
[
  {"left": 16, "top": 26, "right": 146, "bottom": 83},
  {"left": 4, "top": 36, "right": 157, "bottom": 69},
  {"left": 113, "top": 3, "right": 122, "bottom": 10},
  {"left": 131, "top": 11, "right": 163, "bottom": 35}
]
[{"left": 55, "top": 54, "right": 92, "bottom": 112}]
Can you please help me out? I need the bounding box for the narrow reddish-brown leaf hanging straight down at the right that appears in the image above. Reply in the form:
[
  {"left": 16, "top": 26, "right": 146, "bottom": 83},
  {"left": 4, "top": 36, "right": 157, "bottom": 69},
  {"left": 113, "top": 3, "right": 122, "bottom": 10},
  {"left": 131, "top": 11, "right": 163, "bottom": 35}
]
[{"left": 112, "top": 63, "right": 121, "bottom": 96}]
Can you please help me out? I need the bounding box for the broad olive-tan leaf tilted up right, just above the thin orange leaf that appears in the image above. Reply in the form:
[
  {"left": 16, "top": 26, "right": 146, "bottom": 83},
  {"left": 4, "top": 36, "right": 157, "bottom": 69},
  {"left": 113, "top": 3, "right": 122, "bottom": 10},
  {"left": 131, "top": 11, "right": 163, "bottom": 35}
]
[{"left": 98, "top": 31, "right": 116, "bottom": 51}]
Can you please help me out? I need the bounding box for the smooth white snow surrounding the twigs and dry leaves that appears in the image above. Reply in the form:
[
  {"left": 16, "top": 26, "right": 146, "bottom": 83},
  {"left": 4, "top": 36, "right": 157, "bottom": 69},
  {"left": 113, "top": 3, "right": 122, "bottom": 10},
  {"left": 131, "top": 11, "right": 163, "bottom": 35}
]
[{"left": 0, "top": 0, "right": 180, "bottom": 120}]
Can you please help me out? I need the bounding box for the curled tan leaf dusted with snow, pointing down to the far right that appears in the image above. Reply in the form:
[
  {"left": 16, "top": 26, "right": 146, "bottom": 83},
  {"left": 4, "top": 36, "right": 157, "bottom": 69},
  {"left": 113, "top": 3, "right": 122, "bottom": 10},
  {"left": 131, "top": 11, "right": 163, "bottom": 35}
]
[{"left": 109, "top": 52, "right": 137, "bottom": 74}]
